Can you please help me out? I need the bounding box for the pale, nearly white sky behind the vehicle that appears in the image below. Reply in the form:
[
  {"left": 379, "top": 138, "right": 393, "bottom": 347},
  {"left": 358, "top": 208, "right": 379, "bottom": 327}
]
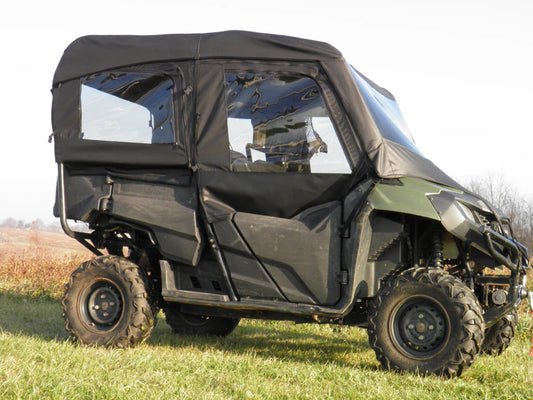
[{"left": 0, "top": 0, "right": 533, "bottom": 222}]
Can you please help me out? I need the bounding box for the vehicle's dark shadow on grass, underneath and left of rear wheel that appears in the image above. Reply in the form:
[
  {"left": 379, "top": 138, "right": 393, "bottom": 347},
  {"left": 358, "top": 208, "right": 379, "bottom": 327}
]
[{"left": 0, "top": 294, "right": 378, "bottom": 370}]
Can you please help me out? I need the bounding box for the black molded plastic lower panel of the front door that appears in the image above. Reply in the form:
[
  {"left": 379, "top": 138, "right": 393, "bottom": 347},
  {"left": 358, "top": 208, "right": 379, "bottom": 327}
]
[{"left": 230, "top": 201, "right": 342, "bottom": 305}]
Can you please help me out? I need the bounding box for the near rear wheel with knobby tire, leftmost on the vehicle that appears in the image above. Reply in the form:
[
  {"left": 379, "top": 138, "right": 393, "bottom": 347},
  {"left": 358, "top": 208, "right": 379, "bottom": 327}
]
[{"left": 62, "top": 255, "right": 154, "bottom": 347}]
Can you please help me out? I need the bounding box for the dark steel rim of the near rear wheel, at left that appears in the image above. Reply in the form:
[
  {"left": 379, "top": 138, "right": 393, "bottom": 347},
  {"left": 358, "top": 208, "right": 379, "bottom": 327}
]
[{"left": 79, "top": 280, "right": 124, "bottom": 332}]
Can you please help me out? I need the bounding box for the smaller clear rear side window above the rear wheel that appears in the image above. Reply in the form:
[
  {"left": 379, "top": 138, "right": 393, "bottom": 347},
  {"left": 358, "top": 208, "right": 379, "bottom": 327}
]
[{"left": 81, "top": 72, "right": 174, "bottom": 143}]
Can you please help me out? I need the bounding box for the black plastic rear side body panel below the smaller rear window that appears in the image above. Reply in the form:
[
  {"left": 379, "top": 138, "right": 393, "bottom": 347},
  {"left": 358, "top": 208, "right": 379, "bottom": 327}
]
[{"left": 54, "top": 165, "right": 205, "bottom": 265}]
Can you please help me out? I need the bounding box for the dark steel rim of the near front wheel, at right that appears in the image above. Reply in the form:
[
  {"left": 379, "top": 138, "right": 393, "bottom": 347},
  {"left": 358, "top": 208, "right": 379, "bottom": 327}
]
[{"left": 389, "top": 296, "right": 450, "bottom": 360}]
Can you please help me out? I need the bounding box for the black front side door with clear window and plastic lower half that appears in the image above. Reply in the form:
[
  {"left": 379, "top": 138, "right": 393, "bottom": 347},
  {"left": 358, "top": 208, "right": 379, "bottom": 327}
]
[{"left": 199, "top": 71, "right": 351, "bottom": 305}]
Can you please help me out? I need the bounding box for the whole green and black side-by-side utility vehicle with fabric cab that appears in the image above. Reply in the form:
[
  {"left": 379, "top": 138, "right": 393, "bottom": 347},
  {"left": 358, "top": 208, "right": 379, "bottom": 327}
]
[{"left": 52, "top": 31, "right": 528, "bottom": 376}]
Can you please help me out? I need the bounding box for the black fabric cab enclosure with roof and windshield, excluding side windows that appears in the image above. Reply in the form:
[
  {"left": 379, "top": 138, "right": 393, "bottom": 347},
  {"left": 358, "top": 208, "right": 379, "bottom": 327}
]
[{"left": 52, "top": 31, "right": 458, "bottom": 186}]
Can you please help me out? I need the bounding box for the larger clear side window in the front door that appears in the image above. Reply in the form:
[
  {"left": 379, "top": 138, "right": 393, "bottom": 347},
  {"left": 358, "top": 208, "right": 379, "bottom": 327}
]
[{"left": 225, "top": 73, "right": 351, "bottom": 174}]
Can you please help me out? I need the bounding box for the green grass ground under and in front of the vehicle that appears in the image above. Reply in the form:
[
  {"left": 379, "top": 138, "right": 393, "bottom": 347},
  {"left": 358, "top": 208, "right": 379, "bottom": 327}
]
[{"left": 0, "top": 294, "right": 533, "bottom": 400}]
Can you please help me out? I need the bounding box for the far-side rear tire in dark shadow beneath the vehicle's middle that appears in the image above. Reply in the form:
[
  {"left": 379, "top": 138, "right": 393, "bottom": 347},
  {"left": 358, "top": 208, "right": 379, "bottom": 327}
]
[{"left": 163, "top": 304, "right": 240, "bottom": 337}]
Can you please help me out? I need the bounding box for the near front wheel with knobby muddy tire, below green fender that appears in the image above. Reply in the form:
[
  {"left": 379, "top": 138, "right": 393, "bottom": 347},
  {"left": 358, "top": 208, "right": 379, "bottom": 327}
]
[{"left": 368, "top": 268, "right": 485, "bottom": 377}]
